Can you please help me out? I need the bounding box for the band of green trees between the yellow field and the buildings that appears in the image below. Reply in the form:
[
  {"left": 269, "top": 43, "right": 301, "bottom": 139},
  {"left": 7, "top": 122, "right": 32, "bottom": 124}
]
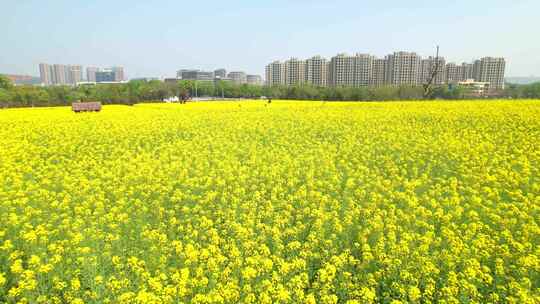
[{"left": 0, "top": 75, "right": 540, "bottom": 108}]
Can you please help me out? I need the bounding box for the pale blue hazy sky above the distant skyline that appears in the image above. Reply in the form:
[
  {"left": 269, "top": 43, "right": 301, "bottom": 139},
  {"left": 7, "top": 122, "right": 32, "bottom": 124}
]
[{"left": 0, "top": 0, "right": 540, "bottom": 77}]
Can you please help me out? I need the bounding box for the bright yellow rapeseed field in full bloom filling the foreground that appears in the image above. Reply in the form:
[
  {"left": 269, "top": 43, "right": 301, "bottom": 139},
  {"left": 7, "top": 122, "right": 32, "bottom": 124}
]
[{"left": 0, "top": 101, "right": 540, "bottom": 304}]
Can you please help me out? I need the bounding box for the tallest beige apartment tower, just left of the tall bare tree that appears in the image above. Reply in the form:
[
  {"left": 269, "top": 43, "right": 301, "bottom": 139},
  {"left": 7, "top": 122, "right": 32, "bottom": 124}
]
[{"left": 385, "top": 52, "right": 420, "bottom": 85}]
